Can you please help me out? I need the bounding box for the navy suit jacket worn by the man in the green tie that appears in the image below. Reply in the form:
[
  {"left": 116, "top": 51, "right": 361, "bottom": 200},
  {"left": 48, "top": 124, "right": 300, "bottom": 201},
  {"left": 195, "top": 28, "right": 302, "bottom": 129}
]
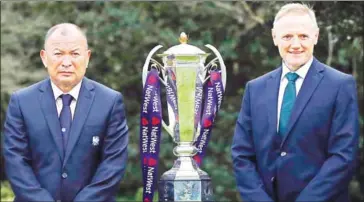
[{"left": 232, "top": 58, "right": 359, "bottom": 202}]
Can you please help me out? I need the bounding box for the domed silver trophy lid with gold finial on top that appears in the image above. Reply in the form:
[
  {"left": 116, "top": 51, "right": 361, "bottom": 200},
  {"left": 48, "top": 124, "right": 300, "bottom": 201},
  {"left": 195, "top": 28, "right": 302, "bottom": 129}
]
[{"left": 162, "top": 32, "right": 206, "bottom": 56}]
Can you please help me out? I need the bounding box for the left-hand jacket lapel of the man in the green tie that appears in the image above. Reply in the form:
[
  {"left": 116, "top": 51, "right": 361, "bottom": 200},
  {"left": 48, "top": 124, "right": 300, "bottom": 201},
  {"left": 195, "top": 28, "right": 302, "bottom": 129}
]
[{"left": 265, "top": 67, "right": 282, "bottom": 135}]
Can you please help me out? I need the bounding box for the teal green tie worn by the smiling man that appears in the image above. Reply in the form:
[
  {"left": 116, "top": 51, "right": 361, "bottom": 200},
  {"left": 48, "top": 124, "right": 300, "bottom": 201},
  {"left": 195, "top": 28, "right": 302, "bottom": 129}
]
[{"left": 278, "top": 72, "right": 298, "bottom": 137}]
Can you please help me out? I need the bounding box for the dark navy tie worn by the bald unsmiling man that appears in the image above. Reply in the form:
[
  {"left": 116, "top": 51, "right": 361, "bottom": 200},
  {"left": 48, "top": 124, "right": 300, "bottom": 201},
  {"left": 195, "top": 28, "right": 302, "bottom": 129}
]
[{"left": 59, "top": 94, "right": 73, "bottom": 150}]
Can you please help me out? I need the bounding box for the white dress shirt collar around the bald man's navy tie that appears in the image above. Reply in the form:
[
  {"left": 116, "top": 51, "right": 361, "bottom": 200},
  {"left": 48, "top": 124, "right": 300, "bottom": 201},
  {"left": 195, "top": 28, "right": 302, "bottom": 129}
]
[{"left": 51, "top": 80, "right": 82, "bottom": 119}]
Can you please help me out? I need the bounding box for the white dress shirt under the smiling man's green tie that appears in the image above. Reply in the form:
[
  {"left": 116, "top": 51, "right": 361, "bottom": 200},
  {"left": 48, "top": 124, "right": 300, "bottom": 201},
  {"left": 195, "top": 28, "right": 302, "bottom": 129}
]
[{"left": 277, "top": 57, "right": 313, "bottom": 132}]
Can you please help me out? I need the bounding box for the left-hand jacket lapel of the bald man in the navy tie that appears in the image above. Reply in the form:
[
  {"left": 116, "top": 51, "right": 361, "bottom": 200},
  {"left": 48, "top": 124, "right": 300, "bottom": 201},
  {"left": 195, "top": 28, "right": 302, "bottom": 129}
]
[{"left": 39, "top": 79, "right": 64, "bottom": 161}]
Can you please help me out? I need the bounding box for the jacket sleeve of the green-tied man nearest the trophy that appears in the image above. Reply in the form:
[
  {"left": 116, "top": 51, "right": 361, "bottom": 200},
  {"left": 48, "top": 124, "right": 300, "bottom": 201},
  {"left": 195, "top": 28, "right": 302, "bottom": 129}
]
[{"left": 231, "top": 83, "right": 273, "bottom": 201}]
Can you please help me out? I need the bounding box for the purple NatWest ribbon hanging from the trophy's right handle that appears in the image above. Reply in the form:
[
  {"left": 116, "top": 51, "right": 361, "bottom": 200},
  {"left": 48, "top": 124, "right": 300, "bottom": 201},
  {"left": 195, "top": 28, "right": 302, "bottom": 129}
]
[{"left": 193, "top": 70, "right": 224, "bottom": 166}]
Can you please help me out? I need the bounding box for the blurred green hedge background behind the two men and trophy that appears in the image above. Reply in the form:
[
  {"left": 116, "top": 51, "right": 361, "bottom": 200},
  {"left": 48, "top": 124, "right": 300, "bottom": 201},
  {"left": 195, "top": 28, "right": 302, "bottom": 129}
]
[{"left": 0, "top": 1, "right": 364, "bottom": 202}]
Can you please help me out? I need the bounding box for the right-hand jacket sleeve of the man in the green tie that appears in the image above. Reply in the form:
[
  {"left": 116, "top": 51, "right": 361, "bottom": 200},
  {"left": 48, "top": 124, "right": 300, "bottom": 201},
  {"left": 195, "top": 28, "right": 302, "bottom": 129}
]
[{"left": 297, "top": 77, "right": 359, "bottom": 201}]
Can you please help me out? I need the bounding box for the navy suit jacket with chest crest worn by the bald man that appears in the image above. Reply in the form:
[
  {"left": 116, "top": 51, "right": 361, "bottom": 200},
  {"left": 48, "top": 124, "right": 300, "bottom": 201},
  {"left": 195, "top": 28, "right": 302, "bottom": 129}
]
[{"left": 4, "top": 78, "right": 128, "bottom": 202}]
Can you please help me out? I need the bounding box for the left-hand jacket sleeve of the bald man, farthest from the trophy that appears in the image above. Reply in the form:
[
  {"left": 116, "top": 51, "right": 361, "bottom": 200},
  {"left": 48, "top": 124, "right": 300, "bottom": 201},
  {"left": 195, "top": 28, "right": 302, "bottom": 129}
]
[{"left": 4, "top": 93, "right": 54, "bottom": 201}]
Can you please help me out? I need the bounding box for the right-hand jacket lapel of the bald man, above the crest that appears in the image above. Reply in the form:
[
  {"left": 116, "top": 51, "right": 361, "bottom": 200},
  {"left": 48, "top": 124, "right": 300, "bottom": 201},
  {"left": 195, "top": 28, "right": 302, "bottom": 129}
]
[{"left": 63, "top": 78, "right": 95, "bottom": 166}]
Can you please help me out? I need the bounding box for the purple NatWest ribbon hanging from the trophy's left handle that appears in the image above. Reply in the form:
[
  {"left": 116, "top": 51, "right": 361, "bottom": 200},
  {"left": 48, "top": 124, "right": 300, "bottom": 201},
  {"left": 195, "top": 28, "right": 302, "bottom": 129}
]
[{"left": 140, "top": 68, "right": 162, "bottom": 202}]
